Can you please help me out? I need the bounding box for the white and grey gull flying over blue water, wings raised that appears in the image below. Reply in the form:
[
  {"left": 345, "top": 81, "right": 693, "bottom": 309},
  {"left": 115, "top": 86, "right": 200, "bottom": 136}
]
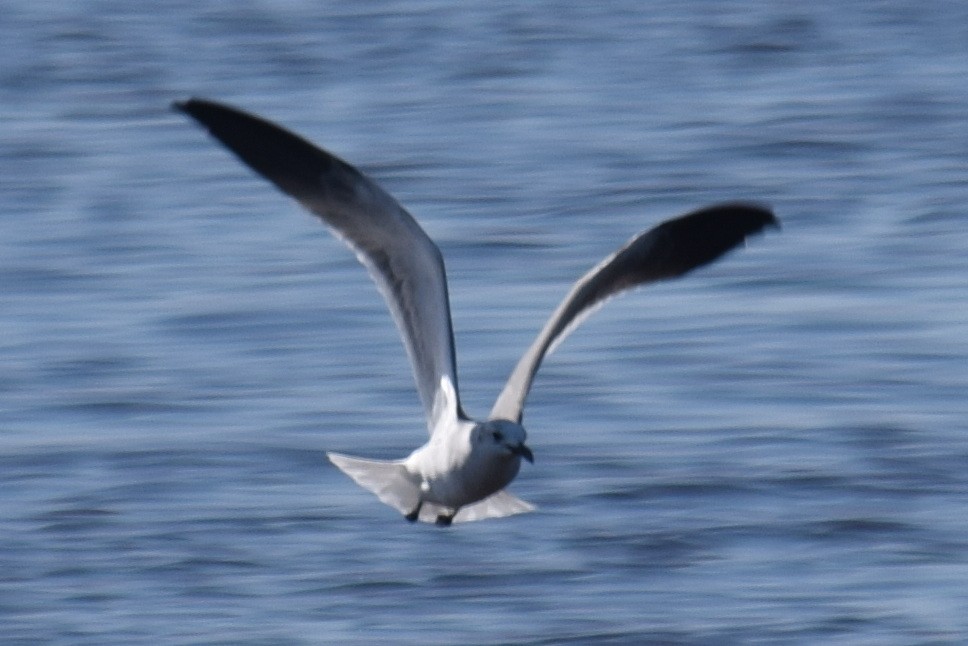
[{"left": 173, "top": 98, "right": 779, "bottom": 526}]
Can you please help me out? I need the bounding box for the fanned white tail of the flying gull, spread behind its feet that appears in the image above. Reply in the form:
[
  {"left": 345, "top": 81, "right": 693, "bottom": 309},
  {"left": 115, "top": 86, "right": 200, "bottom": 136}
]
[{"left": 326, "top": 453, "right": 535, "bottom": 523}]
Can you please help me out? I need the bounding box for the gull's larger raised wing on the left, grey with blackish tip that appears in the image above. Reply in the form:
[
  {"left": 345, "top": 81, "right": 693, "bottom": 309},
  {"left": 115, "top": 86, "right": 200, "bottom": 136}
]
[{"left": 174, "top": 99, "right": 466, "bottom": 433}]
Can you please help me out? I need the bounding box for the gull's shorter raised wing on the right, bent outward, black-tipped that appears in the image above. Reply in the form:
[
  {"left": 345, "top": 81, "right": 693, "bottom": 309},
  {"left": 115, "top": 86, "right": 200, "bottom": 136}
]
[{"left": 491, "top": 203, "right": 779, "bottom": 423}]
